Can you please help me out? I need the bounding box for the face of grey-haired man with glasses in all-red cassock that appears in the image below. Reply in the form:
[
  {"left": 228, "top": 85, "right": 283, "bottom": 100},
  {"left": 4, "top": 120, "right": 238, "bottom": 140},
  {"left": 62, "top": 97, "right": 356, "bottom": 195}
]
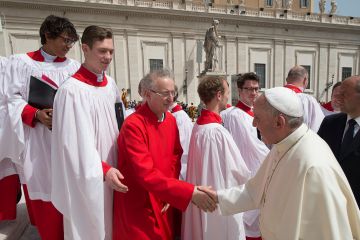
[{"left": 147, "top": 78, "right": 175, "bottom": 116}]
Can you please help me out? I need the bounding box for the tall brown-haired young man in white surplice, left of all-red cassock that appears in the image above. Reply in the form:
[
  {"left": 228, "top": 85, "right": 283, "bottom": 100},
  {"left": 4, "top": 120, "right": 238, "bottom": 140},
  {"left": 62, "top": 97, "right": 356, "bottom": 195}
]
[{"left": 51, "top": 26, "right": 127, "bottom": 240}]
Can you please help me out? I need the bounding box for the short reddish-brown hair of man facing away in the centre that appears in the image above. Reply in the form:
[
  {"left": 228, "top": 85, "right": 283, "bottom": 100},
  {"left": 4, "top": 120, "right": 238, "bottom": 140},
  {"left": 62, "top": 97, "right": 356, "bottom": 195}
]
[{"left": 197, "top": 76, "right": 226, "bottom": 104}]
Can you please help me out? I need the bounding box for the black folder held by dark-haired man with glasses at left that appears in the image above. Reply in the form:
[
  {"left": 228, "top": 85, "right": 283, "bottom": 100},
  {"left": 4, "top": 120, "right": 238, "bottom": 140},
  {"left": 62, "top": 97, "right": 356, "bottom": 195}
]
[{"left": 28, "top": 76, "right": 57, "bottom": 109}]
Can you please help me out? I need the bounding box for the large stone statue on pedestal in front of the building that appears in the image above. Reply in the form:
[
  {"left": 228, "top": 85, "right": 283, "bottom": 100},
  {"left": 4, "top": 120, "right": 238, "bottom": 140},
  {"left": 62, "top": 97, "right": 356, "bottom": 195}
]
[{"left": 203, "top": 20, "right": 221, "bottom": 73}]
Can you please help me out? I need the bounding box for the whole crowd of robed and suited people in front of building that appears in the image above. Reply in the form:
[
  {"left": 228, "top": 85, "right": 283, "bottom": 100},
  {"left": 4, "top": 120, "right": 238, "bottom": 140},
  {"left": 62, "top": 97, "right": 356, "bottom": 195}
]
[{"left": 0, "top": 15, "right": 360, "bottom": 240}]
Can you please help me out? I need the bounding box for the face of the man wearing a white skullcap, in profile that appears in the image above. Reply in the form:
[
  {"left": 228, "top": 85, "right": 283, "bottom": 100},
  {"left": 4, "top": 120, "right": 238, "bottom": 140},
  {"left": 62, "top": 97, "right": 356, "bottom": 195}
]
[{"left": 253, "top": 95, "right": 277, "bottom": 144}]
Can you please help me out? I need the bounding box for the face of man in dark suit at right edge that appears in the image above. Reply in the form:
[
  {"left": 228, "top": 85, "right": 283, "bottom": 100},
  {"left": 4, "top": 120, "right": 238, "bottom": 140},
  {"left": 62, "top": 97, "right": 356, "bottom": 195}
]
[{"left": 339, "top": 77, "right": 360, "bottom": 115}]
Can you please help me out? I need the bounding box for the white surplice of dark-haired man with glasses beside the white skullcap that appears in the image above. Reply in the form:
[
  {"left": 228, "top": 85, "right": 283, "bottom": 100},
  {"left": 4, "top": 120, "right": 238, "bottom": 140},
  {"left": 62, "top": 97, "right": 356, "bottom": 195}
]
[{"left": 221, "top": 107, "right": 269, "bottom": 237}]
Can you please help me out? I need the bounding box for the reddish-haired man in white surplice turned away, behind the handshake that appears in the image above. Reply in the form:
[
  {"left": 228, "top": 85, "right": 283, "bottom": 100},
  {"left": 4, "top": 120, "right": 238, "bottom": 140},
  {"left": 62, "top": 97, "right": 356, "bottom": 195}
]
[{"left": 182, "top": 76, "right": 250, "bottom": 240}]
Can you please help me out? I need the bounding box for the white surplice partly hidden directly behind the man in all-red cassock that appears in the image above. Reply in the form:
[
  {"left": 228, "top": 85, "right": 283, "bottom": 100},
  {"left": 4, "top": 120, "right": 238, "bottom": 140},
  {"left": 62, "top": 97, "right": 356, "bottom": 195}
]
[{"left": 172, "top": 110, "right": 194, "bottom": 180}]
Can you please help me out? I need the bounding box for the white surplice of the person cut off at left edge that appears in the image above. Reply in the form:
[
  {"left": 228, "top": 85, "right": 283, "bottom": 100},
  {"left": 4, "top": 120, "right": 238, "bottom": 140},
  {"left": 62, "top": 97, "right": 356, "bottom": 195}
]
[{"left": 0, "top": 57, "right": 16, "bottom": 180}]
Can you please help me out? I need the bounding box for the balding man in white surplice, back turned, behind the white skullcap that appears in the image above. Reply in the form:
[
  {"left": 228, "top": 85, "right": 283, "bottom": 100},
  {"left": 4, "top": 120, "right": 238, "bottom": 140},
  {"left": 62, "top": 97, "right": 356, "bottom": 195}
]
[{"left": 285, "top": 65, "right": 325, "bottom": 132}]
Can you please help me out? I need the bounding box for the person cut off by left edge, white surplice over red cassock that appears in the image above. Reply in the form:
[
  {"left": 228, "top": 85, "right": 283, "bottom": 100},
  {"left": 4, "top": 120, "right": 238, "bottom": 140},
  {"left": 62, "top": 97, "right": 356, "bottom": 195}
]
[{"left": 0, "top": 57, "right": 21, "bottom": 221}]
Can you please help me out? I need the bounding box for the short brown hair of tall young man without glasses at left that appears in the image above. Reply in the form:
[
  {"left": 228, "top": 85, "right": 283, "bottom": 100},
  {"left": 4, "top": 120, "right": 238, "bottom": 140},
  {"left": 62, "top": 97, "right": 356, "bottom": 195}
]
[{"left": 81, "top": 25, "right": 113, "bottom": 48}]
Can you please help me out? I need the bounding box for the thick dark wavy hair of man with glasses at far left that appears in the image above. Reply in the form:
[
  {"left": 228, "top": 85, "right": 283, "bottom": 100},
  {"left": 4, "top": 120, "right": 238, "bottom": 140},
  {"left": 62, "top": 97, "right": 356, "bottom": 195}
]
[{"left": 39, "top": 15, "right": 79, "bottom": 45}]
